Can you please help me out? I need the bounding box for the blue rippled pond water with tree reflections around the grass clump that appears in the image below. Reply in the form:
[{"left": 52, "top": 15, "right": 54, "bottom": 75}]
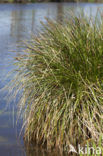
[{"left": 0, "top": 3, "right": 103, "bottom": 156}]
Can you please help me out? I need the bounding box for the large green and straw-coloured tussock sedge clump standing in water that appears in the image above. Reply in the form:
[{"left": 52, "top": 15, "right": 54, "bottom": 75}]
[{"left": 9, "top": 15, "right": 103, "bottom": 154}]
